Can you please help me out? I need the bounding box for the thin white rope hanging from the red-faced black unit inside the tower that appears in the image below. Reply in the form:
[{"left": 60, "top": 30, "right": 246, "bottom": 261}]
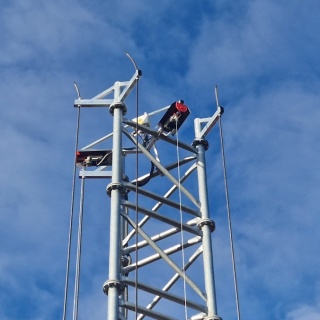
[{"left": 176, "top": 118, "right": 188, "bottom": 320}]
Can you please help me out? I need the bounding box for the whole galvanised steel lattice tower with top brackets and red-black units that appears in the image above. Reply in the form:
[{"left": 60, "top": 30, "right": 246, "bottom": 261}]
[{"left": 69, "top": 60, "right": 223, "bottom": 320}]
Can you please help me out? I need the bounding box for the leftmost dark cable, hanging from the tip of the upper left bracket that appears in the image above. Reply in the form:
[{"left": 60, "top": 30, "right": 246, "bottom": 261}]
[{"left": 62, "top": 107, "right": 80, "bottom": 320}]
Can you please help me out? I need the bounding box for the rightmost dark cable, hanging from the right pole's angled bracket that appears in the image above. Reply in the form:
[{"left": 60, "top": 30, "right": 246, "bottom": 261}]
[{"left": 219, "top": 117, "right": 240, "bottom": 320}]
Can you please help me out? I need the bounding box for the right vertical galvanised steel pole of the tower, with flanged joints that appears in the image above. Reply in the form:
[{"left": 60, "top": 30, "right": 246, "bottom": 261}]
[{"left": 193, "top": 119, "right": 220, "bottom": 319}]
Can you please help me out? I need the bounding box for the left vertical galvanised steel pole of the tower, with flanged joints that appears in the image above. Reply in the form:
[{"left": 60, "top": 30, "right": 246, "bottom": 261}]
[{"left": 104, "top": 82, "right": 126, "bottom": 320}]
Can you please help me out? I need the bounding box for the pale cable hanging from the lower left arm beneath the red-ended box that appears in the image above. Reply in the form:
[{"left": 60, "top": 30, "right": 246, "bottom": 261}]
[{"left": 73, "top": 170, "right": 85, "bottom": 320}]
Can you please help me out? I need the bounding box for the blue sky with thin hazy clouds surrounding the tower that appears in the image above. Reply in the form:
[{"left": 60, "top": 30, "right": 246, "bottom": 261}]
[{"left": 0, "top": 0, "right": 320, "bottom": 320}]
